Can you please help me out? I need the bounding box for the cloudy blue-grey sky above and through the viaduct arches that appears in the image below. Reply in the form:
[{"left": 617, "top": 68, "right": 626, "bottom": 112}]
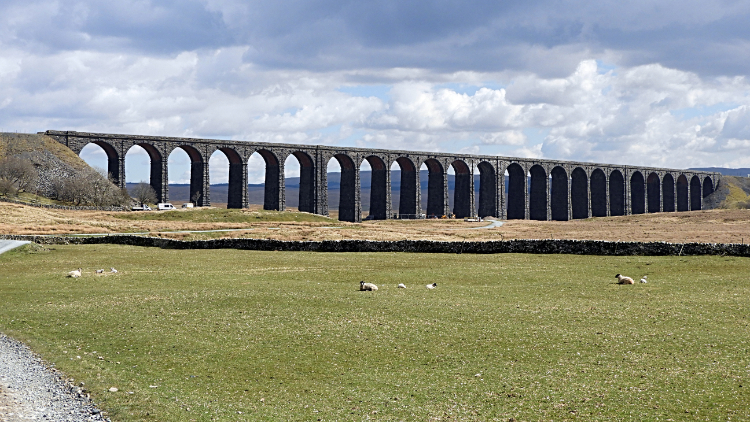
[{"left": 0, "top": 0, "right": 750, "bottom": 183}]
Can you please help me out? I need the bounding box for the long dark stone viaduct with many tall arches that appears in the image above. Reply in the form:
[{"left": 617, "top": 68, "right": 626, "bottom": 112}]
[{"left": 44, "top": 130, "right": 721, "bottom": 222}]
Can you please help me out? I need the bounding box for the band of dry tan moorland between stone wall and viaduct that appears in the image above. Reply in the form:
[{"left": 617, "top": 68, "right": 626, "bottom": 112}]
[{"left": 0, "top": 203, "right": 750, "bottom": 243}]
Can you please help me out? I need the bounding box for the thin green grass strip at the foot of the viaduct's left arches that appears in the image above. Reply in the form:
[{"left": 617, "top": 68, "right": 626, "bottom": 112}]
[{"left": 115, "top": 208, "right": 334, "bottom": 223}]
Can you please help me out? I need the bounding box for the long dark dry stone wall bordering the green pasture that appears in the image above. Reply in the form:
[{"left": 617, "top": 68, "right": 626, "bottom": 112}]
[{"left": 0, "top": 235, "right": 750, "bottom": 257}]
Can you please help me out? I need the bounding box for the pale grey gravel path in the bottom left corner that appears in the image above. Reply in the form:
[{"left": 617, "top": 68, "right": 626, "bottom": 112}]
[{"left": 0, "top": 333, "right": 109, "bottom": 422}]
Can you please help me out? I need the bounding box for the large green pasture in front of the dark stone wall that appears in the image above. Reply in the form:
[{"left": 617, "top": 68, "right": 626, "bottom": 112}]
[{"left": 0, "top": 245, "right": 750, "bottom": 421}]
